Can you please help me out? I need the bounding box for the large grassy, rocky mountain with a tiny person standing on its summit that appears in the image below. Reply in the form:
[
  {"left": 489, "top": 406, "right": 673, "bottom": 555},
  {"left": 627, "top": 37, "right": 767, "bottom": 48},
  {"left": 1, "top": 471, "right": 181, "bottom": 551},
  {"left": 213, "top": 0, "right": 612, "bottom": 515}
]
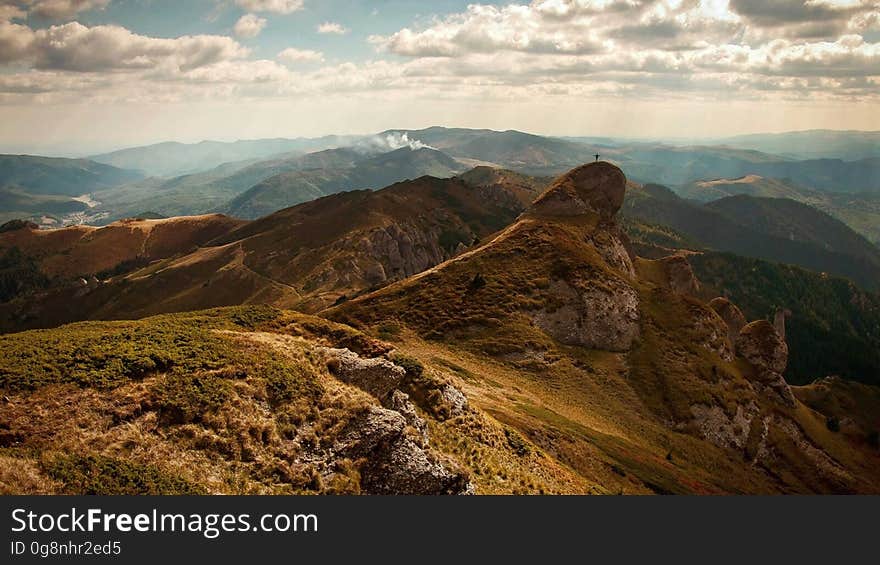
[{"left": 326, "top": 163, "right": 876, "bottom": 493}]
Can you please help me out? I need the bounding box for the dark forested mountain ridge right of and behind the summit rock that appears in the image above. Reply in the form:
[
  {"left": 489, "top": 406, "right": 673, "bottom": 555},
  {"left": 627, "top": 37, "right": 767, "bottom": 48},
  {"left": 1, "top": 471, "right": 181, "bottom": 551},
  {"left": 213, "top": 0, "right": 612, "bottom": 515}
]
[{"left": 624, "top": 185, "right": 880, "bottom": 289}]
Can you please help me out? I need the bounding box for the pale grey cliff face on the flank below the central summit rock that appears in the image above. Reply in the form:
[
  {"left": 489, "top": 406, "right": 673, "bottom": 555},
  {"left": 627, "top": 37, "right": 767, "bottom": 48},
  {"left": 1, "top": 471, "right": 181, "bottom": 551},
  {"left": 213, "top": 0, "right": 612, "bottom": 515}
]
[{"left": 531, "top": 277, "right": 639, "bottom": 351}]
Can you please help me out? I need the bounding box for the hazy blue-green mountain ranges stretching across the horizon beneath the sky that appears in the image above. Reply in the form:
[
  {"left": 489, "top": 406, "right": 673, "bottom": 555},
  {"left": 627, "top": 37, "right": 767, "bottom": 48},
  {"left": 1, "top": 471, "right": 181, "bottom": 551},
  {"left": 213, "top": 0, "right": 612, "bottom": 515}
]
[{"left": 0, "top": 127, "right": 880, "bottom": 247}]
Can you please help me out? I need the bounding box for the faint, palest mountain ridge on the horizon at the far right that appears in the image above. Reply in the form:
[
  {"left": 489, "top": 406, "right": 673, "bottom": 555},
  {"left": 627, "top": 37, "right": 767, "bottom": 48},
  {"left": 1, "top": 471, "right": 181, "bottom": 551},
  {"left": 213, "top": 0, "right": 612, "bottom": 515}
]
[{"left": 715, "top": 130, "right": 880, "bottom": 161}]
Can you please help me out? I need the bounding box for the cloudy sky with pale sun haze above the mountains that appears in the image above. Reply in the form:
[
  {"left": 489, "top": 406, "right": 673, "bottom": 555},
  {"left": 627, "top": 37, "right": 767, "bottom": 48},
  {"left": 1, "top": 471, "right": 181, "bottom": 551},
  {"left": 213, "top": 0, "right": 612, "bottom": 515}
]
[{"left": 0, "top": 0, "right": 880, "bottom": 155}]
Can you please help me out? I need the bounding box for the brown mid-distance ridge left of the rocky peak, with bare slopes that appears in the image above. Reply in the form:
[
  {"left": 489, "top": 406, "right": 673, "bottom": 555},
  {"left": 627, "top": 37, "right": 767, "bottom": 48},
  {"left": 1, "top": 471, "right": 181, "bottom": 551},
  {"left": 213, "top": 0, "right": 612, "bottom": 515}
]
[{"left": 0, "top": 167, "right": 538, "bottom": 329}]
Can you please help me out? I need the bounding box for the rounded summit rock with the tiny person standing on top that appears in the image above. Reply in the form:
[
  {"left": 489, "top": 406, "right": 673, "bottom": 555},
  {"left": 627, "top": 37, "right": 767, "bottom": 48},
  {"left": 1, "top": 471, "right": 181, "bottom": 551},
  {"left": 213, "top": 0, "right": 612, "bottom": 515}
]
[{"left": 530, "top": 161, "right": 626, "bottom": 219}]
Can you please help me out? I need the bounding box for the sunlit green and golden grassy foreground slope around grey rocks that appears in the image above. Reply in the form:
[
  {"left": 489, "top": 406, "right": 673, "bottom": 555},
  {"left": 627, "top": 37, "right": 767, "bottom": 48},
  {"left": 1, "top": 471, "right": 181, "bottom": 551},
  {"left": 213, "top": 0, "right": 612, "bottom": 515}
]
[{"left": 0, "top": 307, "right": 593, "bottom": 494}]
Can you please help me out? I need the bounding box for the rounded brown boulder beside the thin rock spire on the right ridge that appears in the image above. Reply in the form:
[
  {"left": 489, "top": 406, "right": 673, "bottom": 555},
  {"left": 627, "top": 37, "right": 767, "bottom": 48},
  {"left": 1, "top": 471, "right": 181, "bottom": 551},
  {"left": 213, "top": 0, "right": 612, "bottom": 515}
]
[{"left": 736, "top": 320, "right": 795, "bottom": 406}]
